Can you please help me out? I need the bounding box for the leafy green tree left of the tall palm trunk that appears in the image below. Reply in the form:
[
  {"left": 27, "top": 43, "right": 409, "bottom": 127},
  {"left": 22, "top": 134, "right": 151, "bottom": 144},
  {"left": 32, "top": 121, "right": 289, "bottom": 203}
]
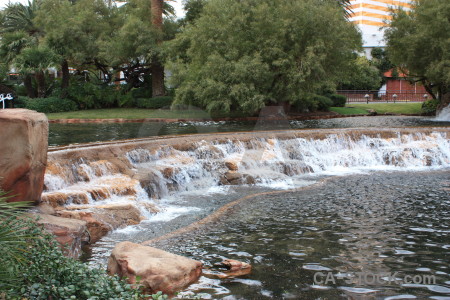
[{"left": 35, "top": 0, "right": 114, "bottom": 97}]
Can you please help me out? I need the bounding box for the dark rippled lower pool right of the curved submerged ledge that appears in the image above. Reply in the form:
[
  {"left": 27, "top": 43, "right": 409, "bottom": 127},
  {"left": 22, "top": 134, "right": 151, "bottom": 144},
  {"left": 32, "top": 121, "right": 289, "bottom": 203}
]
[{"left": 149, "top": 171, "right": 450, "bottom": 299}]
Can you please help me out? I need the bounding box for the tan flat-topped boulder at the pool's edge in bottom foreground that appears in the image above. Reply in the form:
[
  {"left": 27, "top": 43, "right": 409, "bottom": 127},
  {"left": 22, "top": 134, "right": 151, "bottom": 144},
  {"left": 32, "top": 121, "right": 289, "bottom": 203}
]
[{"left": 108, "top": 242, "right": 202, "bottom": 295}]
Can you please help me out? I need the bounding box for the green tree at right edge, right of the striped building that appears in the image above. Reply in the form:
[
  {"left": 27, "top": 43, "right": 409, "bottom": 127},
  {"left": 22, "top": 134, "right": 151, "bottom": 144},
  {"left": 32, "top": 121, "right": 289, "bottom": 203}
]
[{"left": 386, "top": 0, "right": 450, "bottom": 107}]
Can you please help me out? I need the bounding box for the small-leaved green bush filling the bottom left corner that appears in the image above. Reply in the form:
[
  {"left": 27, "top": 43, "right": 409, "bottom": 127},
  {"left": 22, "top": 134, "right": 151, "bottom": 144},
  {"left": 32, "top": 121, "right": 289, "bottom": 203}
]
[{"left": 0, "top": 218, "right": 144, "bottom": 300}]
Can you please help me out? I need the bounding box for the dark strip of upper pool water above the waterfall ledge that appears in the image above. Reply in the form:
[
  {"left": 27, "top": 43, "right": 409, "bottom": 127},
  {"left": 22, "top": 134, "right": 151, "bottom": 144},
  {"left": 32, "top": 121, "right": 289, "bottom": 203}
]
[{"left": 49, "top": 116, "right": 450, "bottom": 146}]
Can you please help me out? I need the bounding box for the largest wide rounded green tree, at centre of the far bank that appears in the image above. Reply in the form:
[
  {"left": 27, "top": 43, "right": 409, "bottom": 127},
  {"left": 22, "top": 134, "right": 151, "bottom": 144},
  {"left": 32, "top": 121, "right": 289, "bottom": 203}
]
[{"left": 170, "top": 0, "right": 361, "bottom": 113}]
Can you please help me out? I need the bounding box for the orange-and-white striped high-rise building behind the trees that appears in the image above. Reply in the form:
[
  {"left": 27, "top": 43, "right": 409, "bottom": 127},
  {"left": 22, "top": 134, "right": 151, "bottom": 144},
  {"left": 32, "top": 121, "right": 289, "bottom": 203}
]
[{"left": 350, "top": 0, "right": 412, "bottom": 57}]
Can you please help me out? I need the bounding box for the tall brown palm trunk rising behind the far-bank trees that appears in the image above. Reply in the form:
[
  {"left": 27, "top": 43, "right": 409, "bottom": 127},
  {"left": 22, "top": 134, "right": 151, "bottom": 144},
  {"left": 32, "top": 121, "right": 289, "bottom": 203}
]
[{"left": 151, "top": 0, "right": 165, "bottom": 97}]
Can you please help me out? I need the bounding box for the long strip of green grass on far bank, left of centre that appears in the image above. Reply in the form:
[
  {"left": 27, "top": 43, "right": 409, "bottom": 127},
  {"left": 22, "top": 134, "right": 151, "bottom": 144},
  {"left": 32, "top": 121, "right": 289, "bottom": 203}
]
[{"left": 47, "top": 108, "right": 248, "bottom": 120}]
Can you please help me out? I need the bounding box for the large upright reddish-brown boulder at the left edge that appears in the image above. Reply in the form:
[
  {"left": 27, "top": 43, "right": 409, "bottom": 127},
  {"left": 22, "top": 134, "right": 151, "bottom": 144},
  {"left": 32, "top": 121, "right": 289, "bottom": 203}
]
[{"left": 0, "top": 109, "right": 48, "bottom": 203}]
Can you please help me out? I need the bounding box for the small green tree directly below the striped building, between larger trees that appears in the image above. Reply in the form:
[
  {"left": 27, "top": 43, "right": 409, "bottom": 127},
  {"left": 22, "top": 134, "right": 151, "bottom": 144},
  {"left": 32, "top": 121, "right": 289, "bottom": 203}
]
[{"left": 339, "top": 56, "right": 382, "bottom": 90}]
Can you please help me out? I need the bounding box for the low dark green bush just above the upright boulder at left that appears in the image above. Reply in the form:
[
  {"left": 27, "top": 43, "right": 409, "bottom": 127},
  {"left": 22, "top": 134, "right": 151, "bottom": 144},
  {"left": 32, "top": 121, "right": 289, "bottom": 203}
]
[{"left": 14, "top": 96, "right": 78, "bottom": 113}]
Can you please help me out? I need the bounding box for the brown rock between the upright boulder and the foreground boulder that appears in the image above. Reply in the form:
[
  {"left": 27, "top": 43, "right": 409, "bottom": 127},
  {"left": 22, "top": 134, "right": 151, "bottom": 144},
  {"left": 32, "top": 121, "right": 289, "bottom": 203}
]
[{"left": 32, "top": 214, "right": 89, "bottom": 258}]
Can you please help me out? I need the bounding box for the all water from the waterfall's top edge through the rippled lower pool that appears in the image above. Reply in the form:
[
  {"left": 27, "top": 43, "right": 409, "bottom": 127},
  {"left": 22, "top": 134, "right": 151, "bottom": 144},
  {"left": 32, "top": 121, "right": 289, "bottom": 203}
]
[{"left": 43, "top": 125, "right": 450, "bottom": 299}]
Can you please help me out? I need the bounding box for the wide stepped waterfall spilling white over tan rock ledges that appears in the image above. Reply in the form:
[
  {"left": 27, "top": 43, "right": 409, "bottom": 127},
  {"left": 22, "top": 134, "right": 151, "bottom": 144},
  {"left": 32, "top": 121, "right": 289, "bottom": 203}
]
[{"left": 42, "top": 129, "right": 450, "bottom": 234}]
